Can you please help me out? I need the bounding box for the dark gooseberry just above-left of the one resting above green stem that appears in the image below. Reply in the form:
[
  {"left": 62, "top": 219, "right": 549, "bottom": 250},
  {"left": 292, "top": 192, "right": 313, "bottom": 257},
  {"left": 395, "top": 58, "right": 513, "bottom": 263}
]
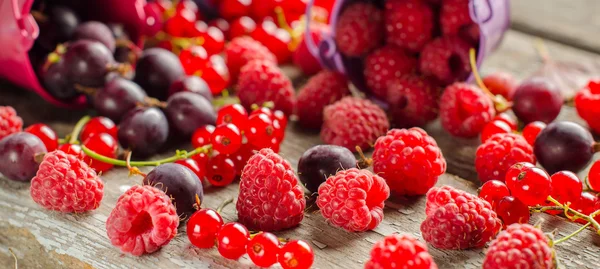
[{"left": 93, "top": 77, "right": 146, "bottom": 122}]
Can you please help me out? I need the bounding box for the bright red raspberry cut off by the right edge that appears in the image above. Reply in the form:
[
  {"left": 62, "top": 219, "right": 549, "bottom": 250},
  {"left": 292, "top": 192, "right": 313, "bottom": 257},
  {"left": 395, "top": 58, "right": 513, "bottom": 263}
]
[{"left": 576, "top": 80, "right": 600, "bottom": 133}]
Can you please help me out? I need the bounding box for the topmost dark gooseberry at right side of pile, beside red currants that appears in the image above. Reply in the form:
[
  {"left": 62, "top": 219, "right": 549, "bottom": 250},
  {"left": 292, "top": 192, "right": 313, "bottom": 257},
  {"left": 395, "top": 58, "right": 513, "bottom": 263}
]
[{"left": 133, "top": 48, "right": 185, "bottom": 100}]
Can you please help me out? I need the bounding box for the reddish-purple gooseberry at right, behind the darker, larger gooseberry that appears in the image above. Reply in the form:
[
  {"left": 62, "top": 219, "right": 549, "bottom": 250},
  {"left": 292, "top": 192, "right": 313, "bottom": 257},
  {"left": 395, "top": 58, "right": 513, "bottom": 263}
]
[{"left": 512, "top": 77, "right": 563, "bottom": 124}]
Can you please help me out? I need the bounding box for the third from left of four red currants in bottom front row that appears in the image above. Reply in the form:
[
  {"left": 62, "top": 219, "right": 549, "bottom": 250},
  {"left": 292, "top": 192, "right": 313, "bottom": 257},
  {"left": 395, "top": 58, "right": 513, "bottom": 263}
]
[{"left": 246, "top": 233, "right": 279, "bottom": 268}]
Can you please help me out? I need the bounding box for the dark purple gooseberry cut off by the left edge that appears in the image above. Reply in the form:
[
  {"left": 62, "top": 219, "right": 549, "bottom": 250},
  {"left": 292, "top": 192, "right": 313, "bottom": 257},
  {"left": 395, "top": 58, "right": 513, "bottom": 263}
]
[{"left": 0, "top": 133, "right": 48, "bottom": 181}]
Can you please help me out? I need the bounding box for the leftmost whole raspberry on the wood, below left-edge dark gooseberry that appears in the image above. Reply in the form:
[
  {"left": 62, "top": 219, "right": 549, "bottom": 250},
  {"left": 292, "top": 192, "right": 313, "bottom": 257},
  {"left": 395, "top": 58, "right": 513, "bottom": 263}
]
[{"left": 30, "top": 150, "right": 104, "bottom": 213}]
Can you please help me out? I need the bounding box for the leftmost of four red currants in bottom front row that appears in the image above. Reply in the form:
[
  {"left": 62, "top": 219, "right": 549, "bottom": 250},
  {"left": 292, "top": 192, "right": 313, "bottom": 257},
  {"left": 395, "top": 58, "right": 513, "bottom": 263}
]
[{"left": 186, "top": 208, "right": 223, "bottom": 248}]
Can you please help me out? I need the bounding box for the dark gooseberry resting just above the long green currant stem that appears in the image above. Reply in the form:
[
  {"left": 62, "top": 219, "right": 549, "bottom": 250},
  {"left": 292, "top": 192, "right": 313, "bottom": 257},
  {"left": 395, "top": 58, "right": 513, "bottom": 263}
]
[{"left": 118, "top": 107, "right": 169, "bottom": 157}]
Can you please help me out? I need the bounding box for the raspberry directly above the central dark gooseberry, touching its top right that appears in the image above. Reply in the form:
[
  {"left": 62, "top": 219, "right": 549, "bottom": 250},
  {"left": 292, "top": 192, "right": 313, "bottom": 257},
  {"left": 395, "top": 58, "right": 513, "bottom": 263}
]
[{"left": 321, "top": 96, "right": 390, "bottom": 152}]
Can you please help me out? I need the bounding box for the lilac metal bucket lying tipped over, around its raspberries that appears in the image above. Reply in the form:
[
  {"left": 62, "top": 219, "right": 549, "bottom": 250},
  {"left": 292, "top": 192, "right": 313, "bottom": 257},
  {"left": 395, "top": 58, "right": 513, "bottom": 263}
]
[{"left": 305, "top": 0, "right": 510, "bottom": 92}]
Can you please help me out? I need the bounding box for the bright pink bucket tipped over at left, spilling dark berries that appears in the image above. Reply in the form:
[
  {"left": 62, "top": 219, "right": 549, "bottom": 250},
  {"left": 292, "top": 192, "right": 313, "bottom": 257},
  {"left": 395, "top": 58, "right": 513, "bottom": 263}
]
[{"left": 0, "top": 0, "right": 160, "bottom": 107}]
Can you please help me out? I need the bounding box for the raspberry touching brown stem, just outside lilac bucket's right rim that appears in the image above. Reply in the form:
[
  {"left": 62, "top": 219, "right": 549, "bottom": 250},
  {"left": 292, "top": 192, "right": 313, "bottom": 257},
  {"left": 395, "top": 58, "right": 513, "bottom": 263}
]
[{"left": 440, "top": 82, "right": 496, "bottom": 137}]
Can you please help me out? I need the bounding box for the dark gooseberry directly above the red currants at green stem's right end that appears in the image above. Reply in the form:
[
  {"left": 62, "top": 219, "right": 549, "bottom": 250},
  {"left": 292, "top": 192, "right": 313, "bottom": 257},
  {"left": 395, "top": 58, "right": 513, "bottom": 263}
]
[{"left": 165, "top": 92, "right": 217, "bottom": 137}]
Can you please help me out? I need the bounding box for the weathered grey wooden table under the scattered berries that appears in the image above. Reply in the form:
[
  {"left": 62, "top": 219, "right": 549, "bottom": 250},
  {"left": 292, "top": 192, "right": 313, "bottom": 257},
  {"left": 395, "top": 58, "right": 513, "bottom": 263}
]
[{"left": 0, "top": 0, "right": 600, "bottom": 268}]
